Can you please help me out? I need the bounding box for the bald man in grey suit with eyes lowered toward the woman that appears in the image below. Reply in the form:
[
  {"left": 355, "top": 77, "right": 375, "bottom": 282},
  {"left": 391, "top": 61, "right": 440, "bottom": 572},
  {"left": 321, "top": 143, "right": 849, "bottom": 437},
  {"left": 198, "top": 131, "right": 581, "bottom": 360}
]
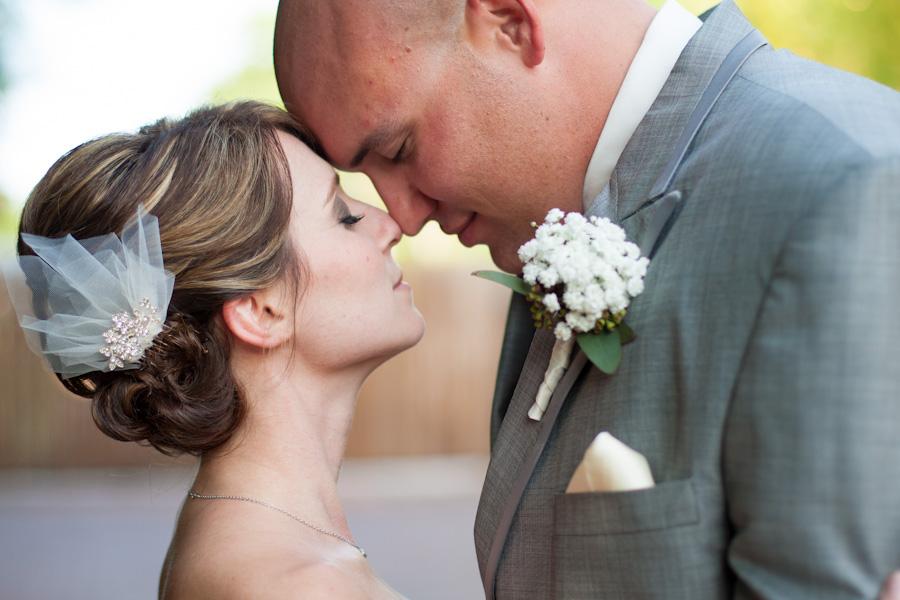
[{"left": 275, "top": 0, "right": 900, "bottom": 600}]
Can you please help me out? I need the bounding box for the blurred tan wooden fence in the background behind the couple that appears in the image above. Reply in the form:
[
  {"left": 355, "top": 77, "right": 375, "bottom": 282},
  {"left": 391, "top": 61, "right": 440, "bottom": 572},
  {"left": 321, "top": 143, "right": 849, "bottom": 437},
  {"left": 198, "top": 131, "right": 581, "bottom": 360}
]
[{"left": 0, "top": 268, "right": 509, "bottom": 468}]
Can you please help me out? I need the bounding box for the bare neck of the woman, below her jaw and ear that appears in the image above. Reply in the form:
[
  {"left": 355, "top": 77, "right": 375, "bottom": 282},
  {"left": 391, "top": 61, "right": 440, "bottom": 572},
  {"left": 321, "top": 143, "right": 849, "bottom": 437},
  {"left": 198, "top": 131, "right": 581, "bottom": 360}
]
[{"left": 194, "top": 356, "right": 367, "bottom": 526}]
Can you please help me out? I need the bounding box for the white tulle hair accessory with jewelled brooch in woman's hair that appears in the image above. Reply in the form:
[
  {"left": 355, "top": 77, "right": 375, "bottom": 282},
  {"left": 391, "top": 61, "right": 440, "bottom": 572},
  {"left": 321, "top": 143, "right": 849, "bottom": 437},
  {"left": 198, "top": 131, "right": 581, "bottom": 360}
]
[{"left": 5, "top": 204, "right": 175, "bottom": 378}]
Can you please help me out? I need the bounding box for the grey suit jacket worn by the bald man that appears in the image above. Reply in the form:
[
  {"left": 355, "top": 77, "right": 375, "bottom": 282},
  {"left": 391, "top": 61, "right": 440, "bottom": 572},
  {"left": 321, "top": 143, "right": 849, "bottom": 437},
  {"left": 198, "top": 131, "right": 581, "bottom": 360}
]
[{"left": 475, "top": 0, "right": 900, "bottom": 600}]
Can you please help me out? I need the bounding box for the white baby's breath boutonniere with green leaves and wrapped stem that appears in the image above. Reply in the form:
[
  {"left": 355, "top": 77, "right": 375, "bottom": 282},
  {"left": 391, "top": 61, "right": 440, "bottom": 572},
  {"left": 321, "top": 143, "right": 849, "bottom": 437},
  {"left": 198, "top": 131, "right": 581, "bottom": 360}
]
[{"left": 475, "top": 208, "right": 650, "bottom": 420}]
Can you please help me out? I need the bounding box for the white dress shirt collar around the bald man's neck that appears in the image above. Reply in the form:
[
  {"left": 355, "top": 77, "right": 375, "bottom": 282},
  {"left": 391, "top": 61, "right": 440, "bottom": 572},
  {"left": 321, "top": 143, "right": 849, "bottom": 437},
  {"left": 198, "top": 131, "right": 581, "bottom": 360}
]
[{"left": 582, "top": 0, "right": 703, "bottom": 212}]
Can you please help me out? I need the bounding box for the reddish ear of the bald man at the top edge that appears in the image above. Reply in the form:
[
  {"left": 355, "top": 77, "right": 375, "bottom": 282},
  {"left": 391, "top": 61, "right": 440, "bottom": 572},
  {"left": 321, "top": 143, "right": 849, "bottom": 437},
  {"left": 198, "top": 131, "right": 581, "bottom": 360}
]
[{"left": 465, "top": 0, "right": 544, "bottom": 67}]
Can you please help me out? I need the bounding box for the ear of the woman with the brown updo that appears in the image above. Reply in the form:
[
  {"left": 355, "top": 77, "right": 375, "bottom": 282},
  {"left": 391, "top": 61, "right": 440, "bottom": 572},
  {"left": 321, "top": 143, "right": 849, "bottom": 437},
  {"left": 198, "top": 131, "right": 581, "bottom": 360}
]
[{"left": 222, "top": 290, "right": 293, "bottom": 348}]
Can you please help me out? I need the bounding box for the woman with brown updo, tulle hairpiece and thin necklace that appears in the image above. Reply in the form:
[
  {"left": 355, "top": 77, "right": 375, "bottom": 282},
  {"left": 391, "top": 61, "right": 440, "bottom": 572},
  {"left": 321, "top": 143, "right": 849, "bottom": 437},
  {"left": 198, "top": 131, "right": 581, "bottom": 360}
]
[{"left": 11, "top": 102, "right": 424, "bottom": 599}]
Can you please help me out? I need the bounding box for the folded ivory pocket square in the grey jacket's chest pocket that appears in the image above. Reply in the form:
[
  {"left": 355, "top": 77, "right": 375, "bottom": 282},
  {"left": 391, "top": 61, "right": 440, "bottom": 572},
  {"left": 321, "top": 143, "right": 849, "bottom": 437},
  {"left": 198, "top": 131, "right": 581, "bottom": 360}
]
[{"left": 566, "top": 431, "right": 654, "bottom": 494}]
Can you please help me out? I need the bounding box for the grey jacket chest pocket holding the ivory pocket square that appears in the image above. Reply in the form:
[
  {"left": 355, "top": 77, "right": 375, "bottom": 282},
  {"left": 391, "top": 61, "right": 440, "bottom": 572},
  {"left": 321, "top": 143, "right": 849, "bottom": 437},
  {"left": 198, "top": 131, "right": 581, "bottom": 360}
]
[{"left": 551, "top": 479, "right": 718, "bottom": 600}]
